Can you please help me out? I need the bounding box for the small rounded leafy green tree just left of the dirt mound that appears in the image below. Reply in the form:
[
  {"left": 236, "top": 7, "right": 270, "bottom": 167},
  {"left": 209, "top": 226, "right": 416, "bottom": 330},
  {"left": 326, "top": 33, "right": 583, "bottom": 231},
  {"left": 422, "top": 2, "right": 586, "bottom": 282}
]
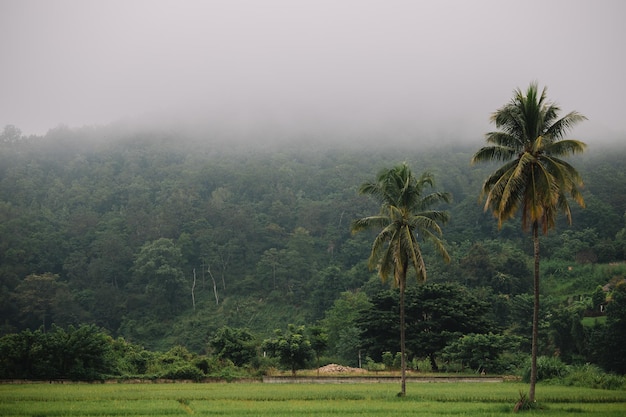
[{"left": 263, "top": 324, "right": 313, "bottom": 376}]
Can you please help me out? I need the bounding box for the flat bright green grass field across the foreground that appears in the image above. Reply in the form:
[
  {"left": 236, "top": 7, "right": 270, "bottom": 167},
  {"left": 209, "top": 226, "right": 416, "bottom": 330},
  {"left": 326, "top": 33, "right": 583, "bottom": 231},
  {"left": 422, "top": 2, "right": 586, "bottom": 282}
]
[{"left": 0, "top": 382, "right": 626, "bottom": 417}]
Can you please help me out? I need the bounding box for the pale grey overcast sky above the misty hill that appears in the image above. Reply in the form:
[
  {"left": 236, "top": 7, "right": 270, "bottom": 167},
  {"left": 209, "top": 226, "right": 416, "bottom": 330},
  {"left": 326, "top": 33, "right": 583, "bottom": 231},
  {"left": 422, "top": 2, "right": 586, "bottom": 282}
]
[{"left": 0, "top": 0, "right": 626, "bottom": 142}]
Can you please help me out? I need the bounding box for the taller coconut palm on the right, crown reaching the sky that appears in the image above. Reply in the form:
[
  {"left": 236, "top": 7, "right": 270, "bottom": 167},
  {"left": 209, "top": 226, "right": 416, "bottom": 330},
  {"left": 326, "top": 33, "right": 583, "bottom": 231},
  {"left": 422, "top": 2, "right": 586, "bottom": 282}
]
[{"left": 472, "top": 83, "right": 586, "bottom": 402}]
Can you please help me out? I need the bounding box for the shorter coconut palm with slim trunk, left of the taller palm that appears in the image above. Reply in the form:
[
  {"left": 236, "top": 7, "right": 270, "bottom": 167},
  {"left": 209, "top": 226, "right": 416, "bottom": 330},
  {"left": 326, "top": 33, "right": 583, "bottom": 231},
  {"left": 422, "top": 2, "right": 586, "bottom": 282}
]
[{"left": 352, "top": 164, "right": 450, "bottom": 396}]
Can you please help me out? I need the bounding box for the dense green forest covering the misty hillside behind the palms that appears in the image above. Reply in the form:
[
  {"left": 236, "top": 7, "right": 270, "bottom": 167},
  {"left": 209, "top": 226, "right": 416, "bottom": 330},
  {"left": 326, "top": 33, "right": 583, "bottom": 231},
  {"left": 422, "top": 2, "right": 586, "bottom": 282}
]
[{"left": 0, "top": 125, "right": 626, "bottom": 373}]
